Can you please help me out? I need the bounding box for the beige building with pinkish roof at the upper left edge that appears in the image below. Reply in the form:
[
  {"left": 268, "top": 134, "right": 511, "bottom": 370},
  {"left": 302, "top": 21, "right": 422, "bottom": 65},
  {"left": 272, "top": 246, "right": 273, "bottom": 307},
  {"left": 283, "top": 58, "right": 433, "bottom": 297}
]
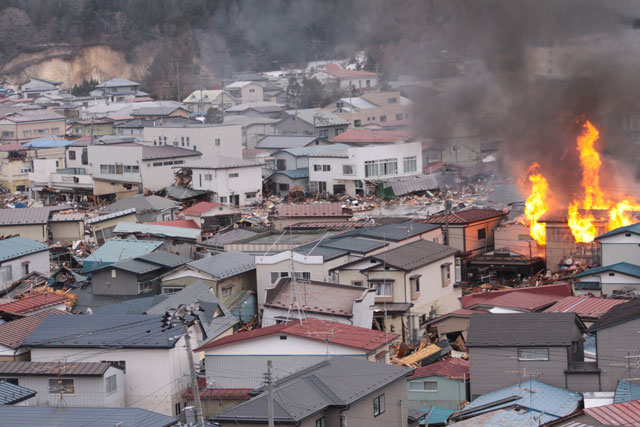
[{"left": 0, "top": 110, "right": 66, "bottom": 144}]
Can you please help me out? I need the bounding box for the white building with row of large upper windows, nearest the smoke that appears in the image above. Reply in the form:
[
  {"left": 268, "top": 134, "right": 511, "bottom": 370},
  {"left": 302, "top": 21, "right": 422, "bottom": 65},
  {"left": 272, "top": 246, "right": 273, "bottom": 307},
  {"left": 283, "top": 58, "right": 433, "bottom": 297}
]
[{"left": 308, "top": 142, "right": 422, "bottom": 196}]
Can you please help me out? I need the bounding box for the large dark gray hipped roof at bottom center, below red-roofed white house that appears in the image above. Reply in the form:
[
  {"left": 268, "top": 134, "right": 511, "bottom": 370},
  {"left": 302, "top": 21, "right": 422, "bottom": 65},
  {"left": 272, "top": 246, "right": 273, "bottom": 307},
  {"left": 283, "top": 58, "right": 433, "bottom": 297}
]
[{"left": 214, "top": 357, "right": 411, "bottom": 424}]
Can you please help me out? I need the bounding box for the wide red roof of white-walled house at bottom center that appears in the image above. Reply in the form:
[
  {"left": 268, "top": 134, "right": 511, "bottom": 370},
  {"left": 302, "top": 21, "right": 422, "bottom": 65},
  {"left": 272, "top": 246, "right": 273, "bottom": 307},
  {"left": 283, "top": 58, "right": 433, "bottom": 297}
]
[{"left": 194, "top": 317, "right": 398, "bottom": 351}]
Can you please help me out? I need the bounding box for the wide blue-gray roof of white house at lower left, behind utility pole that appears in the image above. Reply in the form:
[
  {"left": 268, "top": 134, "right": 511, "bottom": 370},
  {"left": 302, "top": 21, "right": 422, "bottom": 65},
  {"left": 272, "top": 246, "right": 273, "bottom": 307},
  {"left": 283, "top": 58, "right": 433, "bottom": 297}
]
[{"left": 22, "top": 314, "right": 179, "bottom": 349}]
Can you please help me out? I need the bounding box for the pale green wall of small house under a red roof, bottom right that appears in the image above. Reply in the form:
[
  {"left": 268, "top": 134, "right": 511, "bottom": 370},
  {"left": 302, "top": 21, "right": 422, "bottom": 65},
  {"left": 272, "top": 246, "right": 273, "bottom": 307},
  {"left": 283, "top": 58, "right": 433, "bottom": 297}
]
[{"left": 407, "top": 375, "right": 467, "bottom": 411}]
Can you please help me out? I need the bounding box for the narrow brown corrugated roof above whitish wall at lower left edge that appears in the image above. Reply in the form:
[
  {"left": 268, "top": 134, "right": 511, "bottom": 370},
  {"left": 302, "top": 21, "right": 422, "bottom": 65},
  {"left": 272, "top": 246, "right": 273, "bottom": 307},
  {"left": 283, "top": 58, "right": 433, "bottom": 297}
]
[{"left": 0, "top": 362, "right": 112, "bottom": 376}]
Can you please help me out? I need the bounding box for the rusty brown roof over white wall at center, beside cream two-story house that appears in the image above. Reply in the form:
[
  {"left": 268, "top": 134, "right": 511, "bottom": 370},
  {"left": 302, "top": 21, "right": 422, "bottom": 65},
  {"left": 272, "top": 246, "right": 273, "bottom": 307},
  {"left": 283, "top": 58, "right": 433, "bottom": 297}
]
[{"left": 264, "top": 278, "right": 375, "bottom": 317}]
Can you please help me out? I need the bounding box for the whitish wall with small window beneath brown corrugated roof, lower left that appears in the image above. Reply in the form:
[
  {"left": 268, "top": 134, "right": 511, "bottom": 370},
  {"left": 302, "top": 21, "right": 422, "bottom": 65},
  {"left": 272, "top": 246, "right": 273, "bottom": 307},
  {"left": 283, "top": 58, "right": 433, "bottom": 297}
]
[{"left": 18, "top": 367, "right": 125, "bottom": 408}]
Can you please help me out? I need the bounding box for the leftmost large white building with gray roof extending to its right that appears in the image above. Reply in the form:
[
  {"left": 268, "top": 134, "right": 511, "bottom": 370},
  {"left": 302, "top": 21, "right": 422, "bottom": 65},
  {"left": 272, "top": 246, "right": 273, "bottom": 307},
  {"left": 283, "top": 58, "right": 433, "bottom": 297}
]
[{"left": 88, "top": 143, "right": 202, "bottom": 195}]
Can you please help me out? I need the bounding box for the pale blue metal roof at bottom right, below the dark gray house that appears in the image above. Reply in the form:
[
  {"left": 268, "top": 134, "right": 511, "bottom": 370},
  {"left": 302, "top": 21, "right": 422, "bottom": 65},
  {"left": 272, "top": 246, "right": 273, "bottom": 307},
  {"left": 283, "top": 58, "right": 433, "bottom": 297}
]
[{"left": 462, "top": 380, "right": 582, "bottom": 425}]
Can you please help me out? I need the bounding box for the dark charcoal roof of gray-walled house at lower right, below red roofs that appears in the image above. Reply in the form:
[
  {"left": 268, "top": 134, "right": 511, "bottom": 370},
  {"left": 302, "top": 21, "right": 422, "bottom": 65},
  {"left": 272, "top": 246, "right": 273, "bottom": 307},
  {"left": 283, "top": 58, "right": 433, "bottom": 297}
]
[{"left": 467, "top": 313, "right": 586, "bottom": 347}]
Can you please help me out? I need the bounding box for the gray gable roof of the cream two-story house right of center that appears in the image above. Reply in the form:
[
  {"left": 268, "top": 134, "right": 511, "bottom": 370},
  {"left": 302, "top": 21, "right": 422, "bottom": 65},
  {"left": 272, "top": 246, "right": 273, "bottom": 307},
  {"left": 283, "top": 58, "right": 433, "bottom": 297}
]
[{"left": 372, "top": 239, "right": 459, "bottom": 271}]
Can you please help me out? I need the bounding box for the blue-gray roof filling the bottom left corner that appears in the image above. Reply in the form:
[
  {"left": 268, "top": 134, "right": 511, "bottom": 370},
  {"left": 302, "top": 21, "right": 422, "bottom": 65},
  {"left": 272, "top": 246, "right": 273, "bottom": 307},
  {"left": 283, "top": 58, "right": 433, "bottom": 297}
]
[{"left": 0, "top": 405, "right": 178, "bottom": 427}]
